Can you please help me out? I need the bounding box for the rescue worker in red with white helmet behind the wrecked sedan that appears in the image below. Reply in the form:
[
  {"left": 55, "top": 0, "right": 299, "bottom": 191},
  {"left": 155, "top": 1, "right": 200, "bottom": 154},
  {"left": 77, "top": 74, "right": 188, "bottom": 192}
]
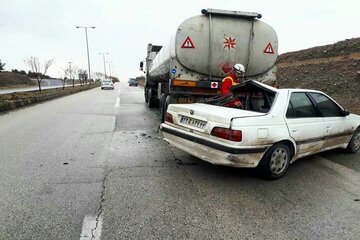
[{"left": 220, "top": 63, "right": 245, "bottom": 108}]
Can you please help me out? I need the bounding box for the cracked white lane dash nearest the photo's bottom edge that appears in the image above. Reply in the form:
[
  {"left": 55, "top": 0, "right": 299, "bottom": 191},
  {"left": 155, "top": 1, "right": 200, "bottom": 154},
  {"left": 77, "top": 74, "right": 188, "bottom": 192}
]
[{"left": 80, "top": 215, "right": 102, "bottom": 240}]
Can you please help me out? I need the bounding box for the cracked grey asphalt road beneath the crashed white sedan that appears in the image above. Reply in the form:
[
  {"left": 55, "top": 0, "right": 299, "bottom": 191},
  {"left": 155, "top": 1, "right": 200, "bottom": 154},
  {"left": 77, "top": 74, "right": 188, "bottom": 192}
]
[{"left": 0, "top": 83, "right": 360, "bottom": 239}]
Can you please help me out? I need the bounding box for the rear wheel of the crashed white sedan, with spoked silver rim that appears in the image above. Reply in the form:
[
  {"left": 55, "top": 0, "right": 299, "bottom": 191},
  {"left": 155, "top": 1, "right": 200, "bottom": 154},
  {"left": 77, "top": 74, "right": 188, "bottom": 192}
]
[{"left": 259, "top": 143, "right": 291, "bottom": 179}]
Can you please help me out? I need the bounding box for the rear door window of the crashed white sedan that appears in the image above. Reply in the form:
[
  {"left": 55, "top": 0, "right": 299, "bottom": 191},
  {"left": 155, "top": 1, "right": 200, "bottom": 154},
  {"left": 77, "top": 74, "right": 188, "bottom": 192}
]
[{"left": 286, "top": 92, "right": 317, "bottom": 118}]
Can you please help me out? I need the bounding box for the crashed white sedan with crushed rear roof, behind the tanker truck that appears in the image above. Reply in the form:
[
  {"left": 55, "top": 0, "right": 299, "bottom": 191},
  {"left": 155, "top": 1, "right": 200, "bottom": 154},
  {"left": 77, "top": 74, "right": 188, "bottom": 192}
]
[{"left": 160, "top": 80, "right": 360, "bottom": 179}]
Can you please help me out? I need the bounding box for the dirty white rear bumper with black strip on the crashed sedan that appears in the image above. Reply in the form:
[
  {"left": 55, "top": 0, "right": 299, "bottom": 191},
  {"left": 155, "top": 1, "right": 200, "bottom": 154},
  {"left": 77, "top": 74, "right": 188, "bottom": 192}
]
[{"left": 160, "top": 124, "right": 269, "bottom": 168}]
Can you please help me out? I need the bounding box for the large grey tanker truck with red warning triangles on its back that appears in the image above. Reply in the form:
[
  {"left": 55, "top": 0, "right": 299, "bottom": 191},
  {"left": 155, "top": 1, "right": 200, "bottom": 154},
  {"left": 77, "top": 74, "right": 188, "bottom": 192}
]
[{"left": 140, "top": 9, "right": 278, "bottom": 122}]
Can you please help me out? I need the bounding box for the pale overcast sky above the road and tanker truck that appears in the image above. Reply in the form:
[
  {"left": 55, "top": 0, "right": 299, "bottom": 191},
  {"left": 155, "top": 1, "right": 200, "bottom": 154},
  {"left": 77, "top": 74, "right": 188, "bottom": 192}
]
[{"left": 0, "top": 0, "right": 360, "bottom": 81}]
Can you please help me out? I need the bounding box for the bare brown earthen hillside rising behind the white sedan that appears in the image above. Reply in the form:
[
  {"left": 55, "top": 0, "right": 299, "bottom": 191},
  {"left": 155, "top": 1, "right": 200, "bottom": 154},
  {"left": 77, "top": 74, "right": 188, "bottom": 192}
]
[{"left": 277, "top": 38, "right": 360, "bottom": 114}]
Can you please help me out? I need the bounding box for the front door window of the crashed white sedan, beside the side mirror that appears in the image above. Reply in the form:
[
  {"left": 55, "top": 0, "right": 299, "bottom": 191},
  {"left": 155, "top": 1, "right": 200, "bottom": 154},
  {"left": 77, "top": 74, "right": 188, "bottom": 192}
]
[{"left": 310, "top": 93, "right": 342, "bottom": 117}]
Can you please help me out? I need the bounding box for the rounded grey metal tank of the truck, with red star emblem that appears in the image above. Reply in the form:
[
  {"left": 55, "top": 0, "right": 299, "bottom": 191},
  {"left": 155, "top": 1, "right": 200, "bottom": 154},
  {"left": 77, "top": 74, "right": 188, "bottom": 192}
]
[{"left": 149, "top": 11, "right": 278, "bottom": 80}]
